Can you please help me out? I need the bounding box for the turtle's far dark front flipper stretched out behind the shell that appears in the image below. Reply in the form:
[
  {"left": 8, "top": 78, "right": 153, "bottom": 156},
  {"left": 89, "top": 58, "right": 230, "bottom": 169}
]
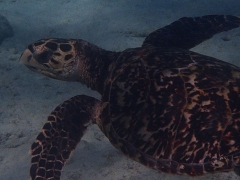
[{"left": 142, "top": 15, "right": 240, "bottom": 49}]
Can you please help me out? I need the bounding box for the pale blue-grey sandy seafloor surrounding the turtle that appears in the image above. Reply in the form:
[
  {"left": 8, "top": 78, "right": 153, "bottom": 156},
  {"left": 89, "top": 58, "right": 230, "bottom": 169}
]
[{"left": 0, "top": 0, "right": 240, "bottom": 180}]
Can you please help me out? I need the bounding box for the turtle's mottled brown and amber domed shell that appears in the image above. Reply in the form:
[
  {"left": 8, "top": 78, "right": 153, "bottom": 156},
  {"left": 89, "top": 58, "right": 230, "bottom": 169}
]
[{"left": 101, "top": 47, "right": 240, "bottom": 175}]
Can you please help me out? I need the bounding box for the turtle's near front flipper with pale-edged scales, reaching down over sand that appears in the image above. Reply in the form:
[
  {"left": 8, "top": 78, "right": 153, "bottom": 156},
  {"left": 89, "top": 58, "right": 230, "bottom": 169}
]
[{"left": 30, "top": 95, "right": 100, "bottom": 180}]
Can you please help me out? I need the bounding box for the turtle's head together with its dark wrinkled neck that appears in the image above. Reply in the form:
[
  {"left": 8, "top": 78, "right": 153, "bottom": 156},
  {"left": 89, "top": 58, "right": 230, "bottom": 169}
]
[{"left": 20, "top": 39, "right": 120, "bottom": 93}]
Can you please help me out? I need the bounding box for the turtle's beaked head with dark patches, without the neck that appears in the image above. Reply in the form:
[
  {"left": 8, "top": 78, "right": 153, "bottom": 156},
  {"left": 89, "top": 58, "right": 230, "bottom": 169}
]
[{"left": 20, "top": 39, "right": 78, "bottom": 81}]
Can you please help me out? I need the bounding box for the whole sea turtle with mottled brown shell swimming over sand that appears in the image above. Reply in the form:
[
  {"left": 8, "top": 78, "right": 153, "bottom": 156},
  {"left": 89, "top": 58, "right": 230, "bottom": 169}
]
[{"left": 20, "top": 15, "right": 240, "bottom": 180}]
